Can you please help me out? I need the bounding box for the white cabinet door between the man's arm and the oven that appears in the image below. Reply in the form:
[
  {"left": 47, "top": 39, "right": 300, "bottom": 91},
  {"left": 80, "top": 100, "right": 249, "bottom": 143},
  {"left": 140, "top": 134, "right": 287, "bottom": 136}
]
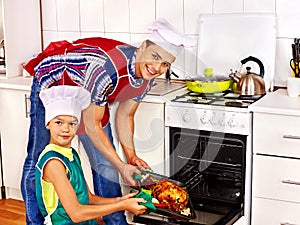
[{"left": 134, "top": 102, "right": 165, "bottom": 174}]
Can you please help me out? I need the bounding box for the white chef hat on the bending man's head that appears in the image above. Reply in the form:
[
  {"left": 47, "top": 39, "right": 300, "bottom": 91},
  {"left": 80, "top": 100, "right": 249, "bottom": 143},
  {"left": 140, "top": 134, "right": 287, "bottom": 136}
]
[{"left": 148, "top": 18, "right": 195, "bottom": 57}]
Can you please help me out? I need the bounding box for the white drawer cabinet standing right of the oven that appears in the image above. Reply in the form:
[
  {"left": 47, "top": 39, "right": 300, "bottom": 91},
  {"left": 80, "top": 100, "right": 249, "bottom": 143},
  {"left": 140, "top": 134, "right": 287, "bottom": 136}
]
[{"left": 252, "top": 112, "right": 300, "bottom": 225}]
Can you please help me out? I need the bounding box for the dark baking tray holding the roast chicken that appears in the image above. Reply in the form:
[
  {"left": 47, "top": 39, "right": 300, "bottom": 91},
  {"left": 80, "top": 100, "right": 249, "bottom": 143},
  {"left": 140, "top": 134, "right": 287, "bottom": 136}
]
[{"left": 132, "top": 170, "right": 196, "bottom": 222}]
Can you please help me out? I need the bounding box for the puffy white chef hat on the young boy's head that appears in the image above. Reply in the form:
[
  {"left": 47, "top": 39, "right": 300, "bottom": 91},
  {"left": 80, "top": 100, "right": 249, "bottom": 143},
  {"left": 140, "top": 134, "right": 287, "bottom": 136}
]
[{"left": 40, "top": 85, "right": 91, "bottom": 125}]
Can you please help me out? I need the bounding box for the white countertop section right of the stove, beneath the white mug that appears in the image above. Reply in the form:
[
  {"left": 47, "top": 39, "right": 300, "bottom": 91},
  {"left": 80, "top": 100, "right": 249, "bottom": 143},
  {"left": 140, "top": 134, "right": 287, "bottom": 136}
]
[{"left": 249, "top": 89, "right": 300, "bottom": 116}]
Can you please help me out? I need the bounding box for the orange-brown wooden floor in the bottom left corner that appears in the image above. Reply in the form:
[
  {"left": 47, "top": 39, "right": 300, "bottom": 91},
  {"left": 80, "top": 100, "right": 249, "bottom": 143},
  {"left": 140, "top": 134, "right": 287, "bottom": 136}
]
[{"left": 0, "top": 199, "right": 26, "bottom": 225}]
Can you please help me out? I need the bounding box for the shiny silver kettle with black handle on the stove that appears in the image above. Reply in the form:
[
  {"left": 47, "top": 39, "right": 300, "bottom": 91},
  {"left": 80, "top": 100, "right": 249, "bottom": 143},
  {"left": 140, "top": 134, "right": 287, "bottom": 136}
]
[{"left": 229, "top": 56, "right": 266, "bottom": 95}]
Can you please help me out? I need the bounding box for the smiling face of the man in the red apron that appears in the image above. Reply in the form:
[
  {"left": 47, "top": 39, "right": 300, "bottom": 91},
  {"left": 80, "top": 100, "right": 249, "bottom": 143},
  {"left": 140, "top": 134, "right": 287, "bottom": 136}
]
[{"left": 135, "top": 41, "right": 175, "bottom": 80}]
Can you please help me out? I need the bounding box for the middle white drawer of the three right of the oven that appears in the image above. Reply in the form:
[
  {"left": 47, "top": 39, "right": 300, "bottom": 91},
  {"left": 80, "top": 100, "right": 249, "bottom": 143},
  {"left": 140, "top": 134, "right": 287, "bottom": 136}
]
[{"left": 252, "top": 155, "right": 300, "bottom": 203}]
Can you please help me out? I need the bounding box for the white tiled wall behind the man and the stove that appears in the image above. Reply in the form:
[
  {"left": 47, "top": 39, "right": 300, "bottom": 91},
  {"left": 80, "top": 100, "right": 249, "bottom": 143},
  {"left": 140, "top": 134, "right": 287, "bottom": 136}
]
[{"left": 41, "top": 0, "right": 300, "bottom": 86}]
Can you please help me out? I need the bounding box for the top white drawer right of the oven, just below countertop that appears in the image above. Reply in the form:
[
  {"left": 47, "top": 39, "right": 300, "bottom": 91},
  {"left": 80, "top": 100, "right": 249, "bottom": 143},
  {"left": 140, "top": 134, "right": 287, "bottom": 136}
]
[{"left": 253, "top": 113, "right": 300, "bottom": 158}]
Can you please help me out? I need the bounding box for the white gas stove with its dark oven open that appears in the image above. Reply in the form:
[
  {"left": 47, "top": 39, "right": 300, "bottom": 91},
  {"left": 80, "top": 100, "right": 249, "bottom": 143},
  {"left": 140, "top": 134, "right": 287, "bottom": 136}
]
[{"left": 134, "top": 89, "right": 262, "bottom": 225}]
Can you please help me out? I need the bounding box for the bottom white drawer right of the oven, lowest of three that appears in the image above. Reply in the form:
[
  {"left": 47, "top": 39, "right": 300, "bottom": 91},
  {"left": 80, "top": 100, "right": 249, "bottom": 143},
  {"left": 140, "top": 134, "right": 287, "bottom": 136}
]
[{"left": 251, "top": 198, "right": 300, "bottom": 225}]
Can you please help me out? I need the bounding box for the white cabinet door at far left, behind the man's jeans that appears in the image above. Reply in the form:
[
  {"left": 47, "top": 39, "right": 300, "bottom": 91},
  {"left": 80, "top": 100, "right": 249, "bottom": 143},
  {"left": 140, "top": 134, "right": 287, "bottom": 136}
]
[{"left": 0, "top": 89, "right": 29, "bottom": 192}]
